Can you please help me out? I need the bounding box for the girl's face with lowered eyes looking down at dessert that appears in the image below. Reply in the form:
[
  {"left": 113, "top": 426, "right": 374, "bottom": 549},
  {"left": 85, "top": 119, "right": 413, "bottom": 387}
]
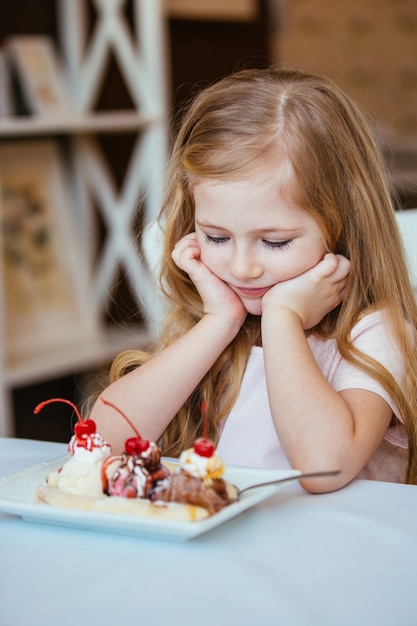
[{"left": 193, "top": 164, "right": 327, "bottom": 315}]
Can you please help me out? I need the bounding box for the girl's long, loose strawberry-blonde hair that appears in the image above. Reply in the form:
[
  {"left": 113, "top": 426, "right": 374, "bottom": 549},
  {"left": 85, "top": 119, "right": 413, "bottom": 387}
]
[{"left": 111, "top": 68, "right": 417, "bottom": 483}]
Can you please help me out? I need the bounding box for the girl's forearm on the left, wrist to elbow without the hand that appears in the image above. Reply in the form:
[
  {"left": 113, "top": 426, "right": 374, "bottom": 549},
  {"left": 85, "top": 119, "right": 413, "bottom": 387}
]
[{"left": 91, "top": 314, "right": 239, "bottom": 453}]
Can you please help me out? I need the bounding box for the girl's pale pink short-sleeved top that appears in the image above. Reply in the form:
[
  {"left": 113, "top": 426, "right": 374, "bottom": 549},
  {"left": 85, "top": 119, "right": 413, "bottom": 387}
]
[{"left": 217, "top": 312, "right": 408, "bottom": 482}]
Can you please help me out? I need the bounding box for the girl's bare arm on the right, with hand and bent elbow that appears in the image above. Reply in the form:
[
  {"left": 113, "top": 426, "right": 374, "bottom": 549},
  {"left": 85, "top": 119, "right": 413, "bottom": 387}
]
[{"left": 262, "top": 254, "right": 392, "bottom": 492}]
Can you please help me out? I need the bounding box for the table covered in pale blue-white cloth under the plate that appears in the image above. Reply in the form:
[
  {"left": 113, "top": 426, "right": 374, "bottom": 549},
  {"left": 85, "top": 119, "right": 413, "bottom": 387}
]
[{"left": 0, "top": 438, "right": 417, "bottom": 626}]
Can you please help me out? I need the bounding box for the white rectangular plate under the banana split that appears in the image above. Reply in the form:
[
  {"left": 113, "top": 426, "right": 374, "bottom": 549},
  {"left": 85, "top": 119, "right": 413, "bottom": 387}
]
[{"left": 0, "top": 456, "right": 300, "bottom": 541}]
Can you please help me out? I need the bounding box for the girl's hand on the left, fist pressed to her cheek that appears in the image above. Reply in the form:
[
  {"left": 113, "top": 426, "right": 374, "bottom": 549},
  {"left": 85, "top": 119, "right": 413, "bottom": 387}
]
[{"left": 172, "top": 233, "right": 246, "bottom": 324}]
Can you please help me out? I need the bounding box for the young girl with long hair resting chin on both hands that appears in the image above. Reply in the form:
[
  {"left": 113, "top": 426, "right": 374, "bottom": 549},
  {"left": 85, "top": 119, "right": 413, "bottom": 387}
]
[{"left": 92, "top": 68, "right": 417, "bottom": 492}]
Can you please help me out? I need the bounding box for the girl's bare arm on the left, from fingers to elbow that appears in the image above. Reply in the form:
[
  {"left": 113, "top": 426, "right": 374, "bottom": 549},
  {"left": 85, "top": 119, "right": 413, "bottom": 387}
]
[{"left": 91, "top": 235, "right": 246, "bottom": 452}]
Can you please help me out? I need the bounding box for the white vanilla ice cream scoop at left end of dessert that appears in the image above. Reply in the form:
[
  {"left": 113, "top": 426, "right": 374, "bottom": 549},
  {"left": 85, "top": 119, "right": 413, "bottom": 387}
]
[{"left": 47, "top": 436, "right": 111, "bottom": 498}]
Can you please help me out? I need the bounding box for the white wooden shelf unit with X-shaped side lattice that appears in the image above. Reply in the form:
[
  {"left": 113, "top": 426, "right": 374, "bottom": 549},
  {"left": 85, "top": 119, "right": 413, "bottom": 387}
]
[{"left": 0, "top": 0, "right": 168, "bottom": 436}]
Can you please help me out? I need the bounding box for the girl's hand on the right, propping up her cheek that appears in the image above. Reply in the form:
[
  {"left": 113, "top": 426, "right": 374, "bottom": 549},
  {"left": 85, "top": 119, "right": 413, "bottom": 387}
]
[{"left": 262, "top": 253, "right": 350, "bottom": 330}]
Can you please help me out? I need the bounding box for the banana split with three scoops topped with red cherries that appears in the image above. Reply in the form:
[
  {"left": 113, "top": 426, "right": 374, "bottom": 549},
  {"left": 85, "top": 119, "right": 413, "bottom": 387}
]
[{"left": 35, "top": 398, "right": 237, "bottom": 521}]
